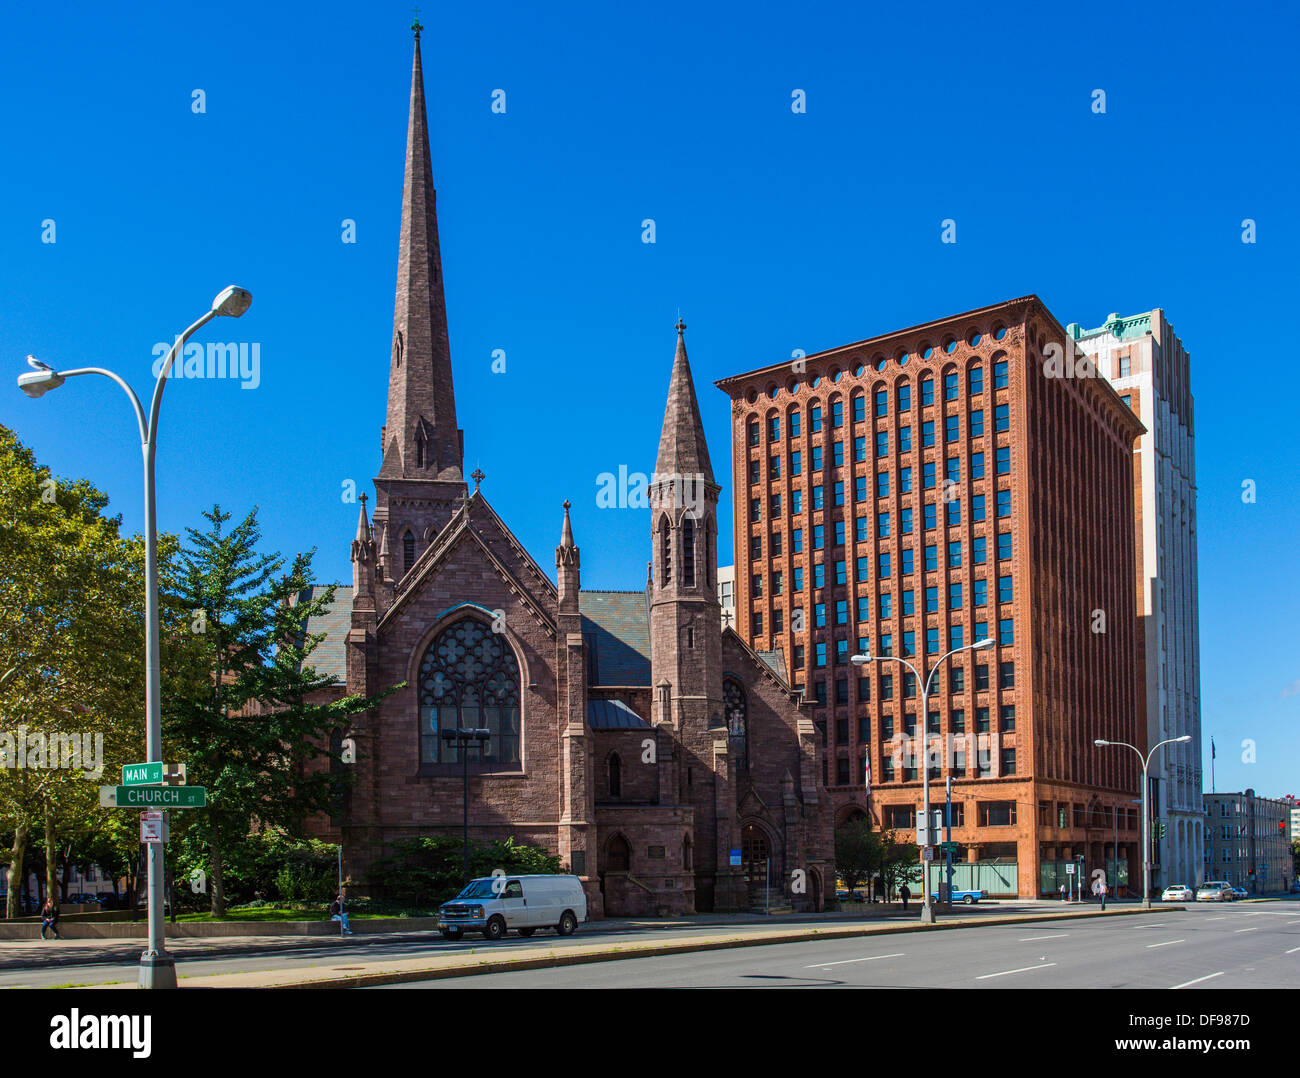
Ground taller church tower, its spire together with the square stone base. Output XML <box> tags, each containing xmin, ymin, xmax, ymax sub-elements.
<box><xmin>374</xmin><ymin>22</ymin><xmax>467</xmax><ymax>589</ymax></box>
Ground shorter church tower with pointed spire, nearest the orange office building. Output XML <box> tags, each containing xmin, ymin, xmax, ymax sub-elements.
<box><xmin>649</xmin><ymin>320</ymin><xmax>733</xmax><ymax>912</ymax></box>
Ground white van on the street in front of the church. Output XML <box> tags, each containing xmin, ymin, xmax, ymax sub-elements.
<box><xmin>438</xmin><ymin>875</ymin><xmax>586</xmax><ymax>940</ymax></box>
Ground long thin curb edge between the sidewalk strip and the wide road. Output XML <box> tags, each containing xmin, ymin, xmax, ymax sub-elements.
<box><xmin>181</xmin><ymin>906</ymin><xmax>1187</xmax><ymax>988</ymax></box>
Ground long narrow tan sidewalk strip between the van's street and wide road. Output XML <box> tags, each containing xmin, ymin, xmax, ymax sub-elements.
<box><xmin>119</xmin><ymin>902</ymin><xmax>1186</xmax><ymax>988</ymax></box>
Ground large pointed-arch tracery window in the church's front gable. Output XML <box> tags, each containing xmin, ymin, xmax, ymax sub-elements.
<box><xmin>420</xmin><ymin>616</ymin><xmax>520</xmax><ymax>770</ymax></box>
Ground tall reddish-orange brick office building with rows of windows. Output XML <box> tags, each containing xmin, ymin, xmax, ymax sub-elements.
<box><xmin>718</xmin><ymin>296</ymin><xmax>1147</xmax><ymax>896</ymax></box>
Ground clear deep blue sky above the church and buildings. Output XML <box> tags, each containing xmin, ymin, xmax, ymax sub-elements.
<box><xmin>0</xmin><ymin>3</ymin><xmax>1300</xmax><ymax>796</ymax></box>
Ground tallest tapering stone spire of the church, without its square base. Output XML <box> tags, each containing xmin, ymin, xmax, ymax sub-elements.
<box><xmin>380</xmin><ymin>27</ymin><xmax>464</xmax><ymax>481</ymax></box>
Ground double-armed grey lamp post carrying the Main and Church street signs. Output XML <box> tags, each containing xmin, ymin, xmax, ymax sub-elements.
<box><xmin>18</xmin><ymin>285</ymin><xmax>252</xmax><ymax>988</ymax></box>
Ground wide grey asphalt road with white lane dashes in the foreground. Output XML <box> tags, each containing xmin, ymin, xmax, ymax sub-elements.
<box><xmin>387</xmin><ymin>901</ymin><xmax>1300</xmax><ymax>991</ymax></box>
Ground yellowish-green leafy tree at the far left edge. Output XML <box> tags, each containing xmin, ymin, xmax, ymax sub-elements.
<box><xmin>0</xmin><ymin>427</ymin><xmax>157</xmax><ymax>917</ymax></box>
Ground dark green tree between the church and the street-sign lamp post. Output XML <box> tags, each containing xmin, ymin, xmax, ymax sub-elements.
<box><xmin>164</xmin><ymin>506</ymin><xmax>398</xmax><ymax>915</ymax></box>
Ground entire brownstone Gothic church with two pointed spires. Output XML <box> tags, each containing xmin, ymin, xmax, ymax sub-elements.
<box><xmin>308</xmin><ymin>25</ymin><xmax>835</xmax><ymax>917</ymax></box>
